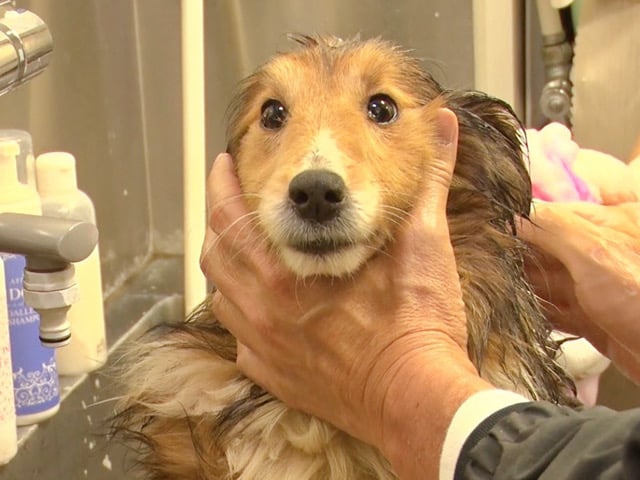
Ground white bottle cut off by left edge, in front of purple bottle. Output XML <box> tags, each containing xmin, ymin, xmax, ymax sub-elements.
<box><xmin>0</xmin><ymin>262</ymin><xmax>18</xmax><ymax>465</ymax></box>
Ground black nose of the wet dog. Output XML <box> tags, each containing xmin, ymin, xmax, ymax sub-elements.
<box><xmin>289</xmin><ymin>170</ymin><xmax>345</xmax><ymax>223</ymax></box>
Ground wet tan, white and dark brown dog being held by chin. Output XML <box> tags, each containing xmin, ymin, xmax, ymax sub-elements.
<box><xmin>115</xmin><ymin>36</ymin><xmax>571</xmax><ymax>480</ymax></box>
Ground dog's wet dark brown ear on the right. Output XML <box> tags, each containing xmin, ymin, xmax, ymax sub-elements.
<box><xmin>444</xmin><ymin>92</ymin><xmax>531</xmax><ymax>231</ymax></box>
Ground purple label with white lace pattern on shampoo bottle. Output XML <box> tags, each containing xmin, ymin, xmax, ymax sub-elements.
<box><xmin>0</xmin><ymin>253</ymin><xmax>60</xmax><ymax>416</ymax></box>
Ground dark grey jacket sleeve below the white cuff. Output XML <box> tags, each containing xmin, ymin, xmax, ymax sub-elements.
<box><xmin>455</xmin><ymin>402</ymin><xmax>640</xmax><ymax>480</ymax></box>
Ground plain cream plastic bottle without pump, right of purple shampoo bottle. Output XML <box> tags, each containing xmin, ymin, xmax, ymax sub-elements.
<box><xmin>36</xmin><ymin>152</ymin><xmax>107</xmax><ymax>375</ymax></box>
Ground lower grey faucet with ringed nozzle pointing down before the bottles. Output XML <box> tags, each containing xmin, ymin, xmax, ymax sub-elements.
<box><xmin>0</xmin><ymin>213</ymin><xmax>98</xmax><ymax>348</ymax></box>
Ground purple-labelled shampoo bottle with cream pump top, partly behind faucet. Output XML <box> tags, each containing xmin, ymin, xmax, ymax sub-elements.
<box><xmin>0</xmin><ymin>141</ymin><xmax>60</xmax><ymax>425</ymax></box>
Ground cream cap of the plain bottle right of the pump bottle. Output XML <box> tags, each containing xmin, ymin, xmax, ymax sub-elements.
<box><xmin>36</xmin><ymin>152</ymin><xmax>78</xmax><ymax>197</ymax></box>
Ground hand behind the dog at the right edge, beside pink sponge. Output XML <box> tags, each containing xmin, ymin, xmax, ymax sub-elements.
<box><xmin>519</xmin><ymin>203</ymin><xmax>640</xmax><ymax>381</ymax></box>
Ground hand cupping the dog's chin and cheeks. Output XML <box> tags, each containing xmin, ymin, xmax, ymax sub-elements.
<box><xmin>201</xmin><ymin>110</ymin><xmax>491</xmax><ymax>478</ymax></box>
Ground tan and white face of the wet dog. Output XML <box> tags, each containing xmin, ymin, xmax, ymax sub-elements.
<box><xmin>229</xmin><ymin>38</ymin><xmax>438</xmax><ymax>276</ymax></box>
